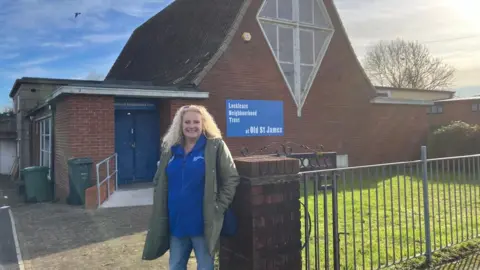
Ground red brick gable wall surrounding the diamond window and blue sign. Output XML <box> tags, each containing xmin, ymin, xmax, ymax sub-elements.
<box><xmin>165</xmin><ymin>0</ymin><xmax>427</xmax><ymax>164</ymax></box>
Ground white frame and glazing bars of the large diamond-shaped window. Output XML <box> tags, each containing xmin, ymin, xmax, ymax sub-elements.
<box><xmin>257</xmin><ymin>0</ymin><xmax>335</xmax><ymax>117</ymax></box>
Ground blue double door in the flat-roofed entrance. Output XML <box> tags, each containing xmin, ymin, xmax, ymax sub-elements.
<box><xmin>115</xmin><ymin>102</ymin><xmax>160</xmax><ymax>185</ymax></box>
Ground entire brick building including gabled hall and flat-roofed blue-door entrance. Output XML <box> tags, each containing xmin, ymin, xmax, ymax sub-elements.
<box><xmin>11</xmin><ymin>0</ymin><xmax>433</xmax><ymax>204</ymax></box>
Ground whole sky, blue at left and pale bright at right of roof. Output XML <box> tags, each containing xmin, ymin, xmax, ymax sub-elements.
<box><xmin>0</xmin><ymin>0</ymin><xmax>480</xmax><ymax>108</ymax></box>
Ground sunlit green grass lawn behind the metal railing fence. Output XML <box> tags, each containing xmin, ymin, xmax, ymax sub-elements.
<box><xmin>300</xmin><ymin>160</ymin><xmax>480</xmax><ymax>269</ymax></box>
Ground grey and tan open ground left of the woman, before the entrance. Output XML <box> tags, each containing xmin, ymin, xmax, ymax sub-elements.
<box><xmin>12</xmin><ymin>203</ymin><xmax>196</xmax><ymax>270</ymax></box>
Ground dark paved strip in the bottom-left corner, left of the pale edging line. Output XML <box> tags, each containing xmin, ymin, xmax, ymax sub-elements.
<box><xmin>0</xmin><ymin>207</ymin><xmax>20</xmax><ymax>270</ymax></box>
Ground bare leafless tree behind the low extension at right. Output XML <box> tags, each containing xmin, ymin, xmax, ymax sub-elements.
<box><xmin>363</xmin><ymin>39</ymin><xmax>455</xmax><ymax>90</ymax></box>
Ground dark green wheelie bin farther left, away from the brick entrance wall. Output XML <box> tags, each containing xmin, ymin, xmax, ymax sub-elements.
<box><xmin>21</xmin><ymin>166</ymin><xmax>53</xmax><ymax>203</ymax></box>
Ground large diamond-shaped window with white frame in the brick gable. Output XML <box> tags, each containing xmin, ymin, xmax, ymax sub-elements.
<box><xmin>258</xmin><ymin>0</ymin><xmax>334</xmax><ymax>115</ymax></box>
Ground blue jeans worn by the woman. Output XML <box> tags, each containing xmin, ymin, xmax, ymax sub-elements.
<box><xmin>169</xmin><ymin>236</ymin><xmax>214</xmax><ymax>270</ymax></box>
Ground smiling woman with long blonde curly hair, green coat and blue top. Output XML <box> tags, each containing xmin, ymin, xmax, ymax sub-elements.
<box><xmin>143</xmin><ymin>105</ymin><xmax>240</xmax><ymax>270</ymax></box>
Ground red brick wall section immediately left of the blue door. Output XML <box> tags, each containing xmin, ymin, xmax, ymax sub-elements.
<box><xmin>54</xmin><ymin>95</ymin><xmax>115</xmax><ymax>200</ymax></box>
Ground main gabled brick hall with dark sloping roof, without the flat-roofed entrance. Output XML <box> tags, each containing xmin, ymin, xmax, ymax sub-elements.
<box><xmin>107</xmin><ymin>0</ymin><xmax>431</xmax><ymax>164</ymax></box>
